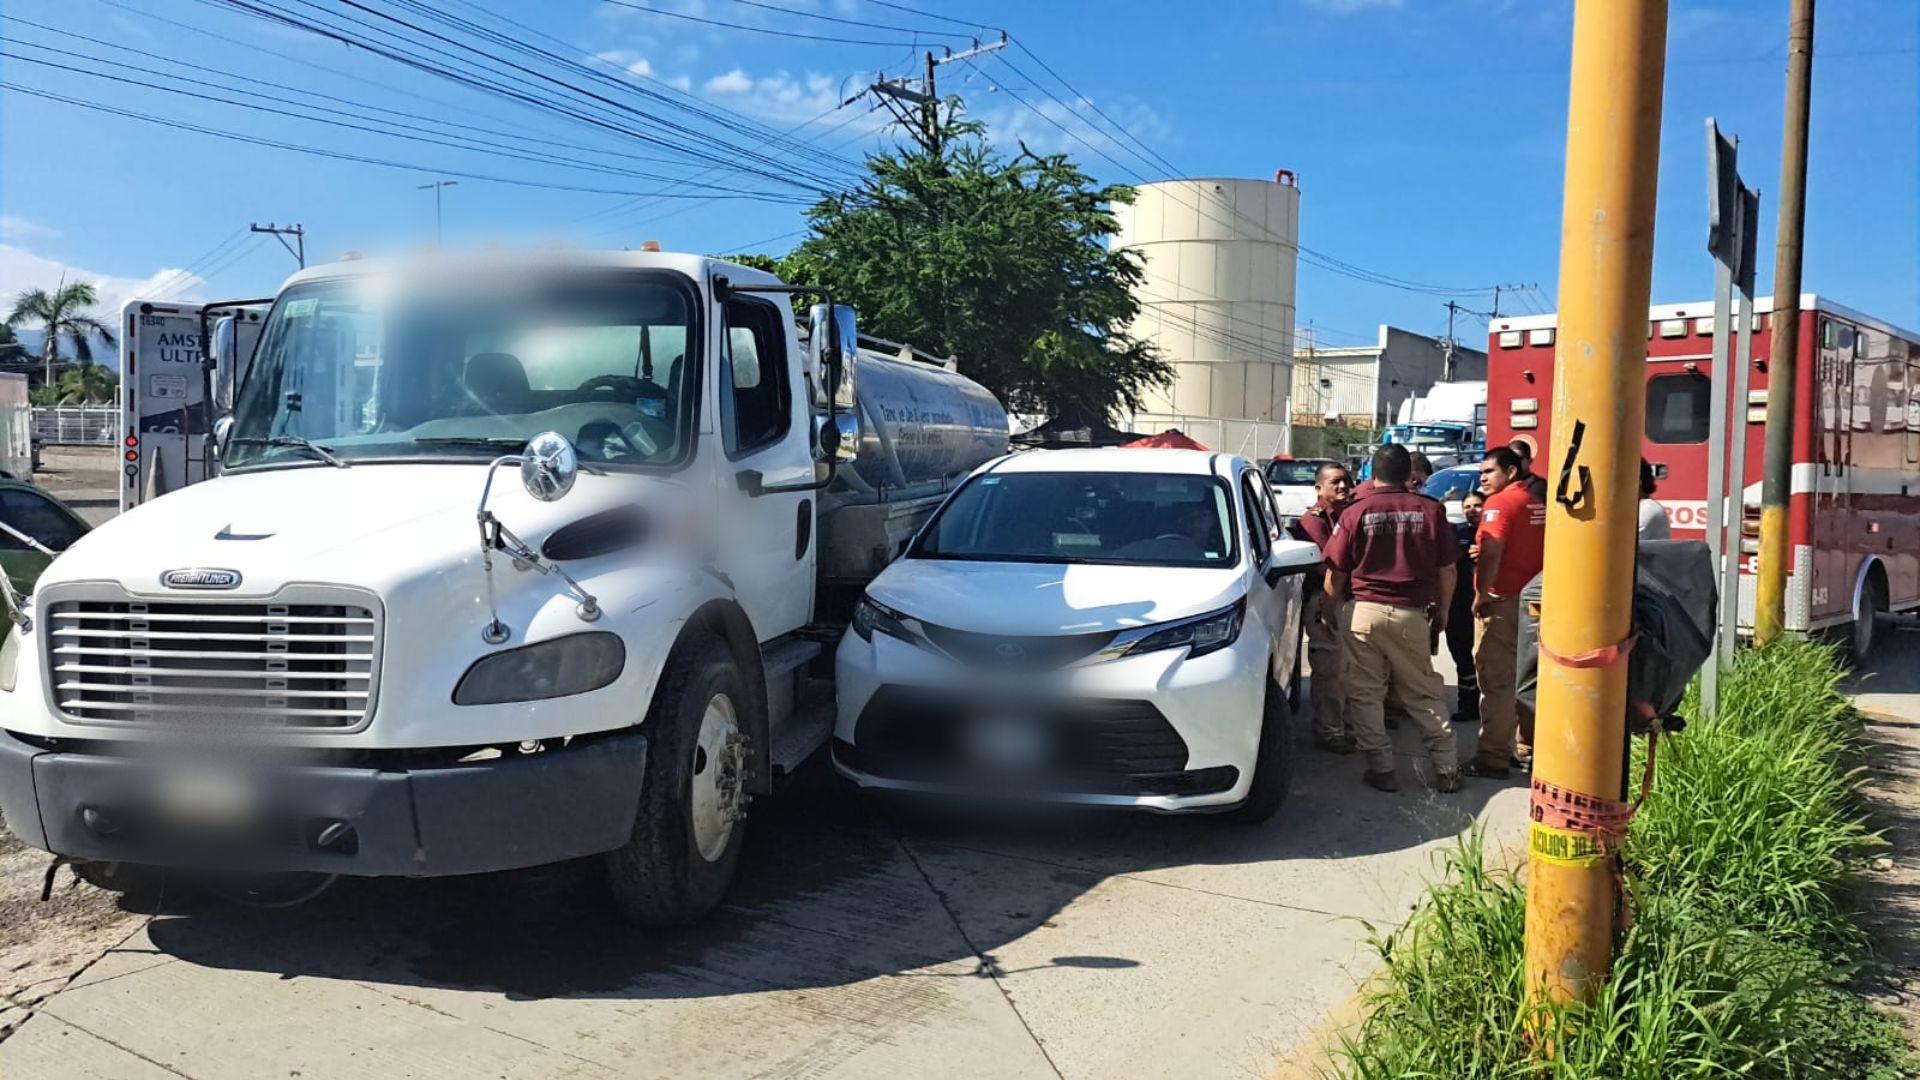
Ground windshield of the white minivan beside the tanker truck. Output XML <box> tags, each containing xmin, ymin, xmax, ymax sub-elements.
<box><xmin>906</xmin><ymin>473</ymin><xmax>1236</xmax><ymax>567</ymax></box>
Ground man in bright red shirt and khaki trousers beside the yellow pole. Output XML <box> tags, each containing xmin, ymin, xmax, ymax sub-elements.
<box><xmin>1463</xmin><ymin>446</ymin><xmax>1548</xmax><ymax>780</ymax></box>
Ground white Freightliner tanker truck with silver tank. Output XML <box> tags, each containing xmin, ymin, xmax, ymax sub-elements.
<box><xmin>0</xmin><ymin>252</ymin><xmax>1006</xmax><ymax>924</ymax></box>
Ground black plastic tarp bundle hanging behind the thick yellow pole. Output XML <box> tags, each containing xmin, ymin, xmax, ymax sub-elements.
<box><xmin>1517</xmin><ymin>540</ymin><xmax>1718</xmax><ymax>728</ymax></box>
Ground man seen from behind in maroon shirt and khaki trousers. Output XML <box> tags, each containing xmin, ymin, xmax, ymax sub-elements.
<box><xmin>1327</xmin><ymin>444</ymin><xmax>1459</xmax><ymax>792</ymax></box>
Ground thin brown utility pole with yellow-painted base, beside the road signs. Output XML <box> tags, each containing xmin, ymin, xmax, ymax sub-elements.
<box><xmin>1753</xmin><ymin>0</ymin><xmax>1812</xmax><ymax>646</ymax></box>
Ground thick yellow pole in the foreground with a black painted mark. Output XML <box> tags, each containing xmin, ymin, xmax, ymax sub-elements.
<box><xmin>1526</xmin><ymin>0</ymin><xmax>1667</xmax><ymax>999</ymax></box>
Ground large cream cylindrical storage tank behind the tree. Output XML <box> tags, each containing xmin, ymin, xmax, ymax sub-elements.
<box><xmin>1114</xmin><ymin>169</ymin><xmax>1300</xmax><ymax>423</ymax></box>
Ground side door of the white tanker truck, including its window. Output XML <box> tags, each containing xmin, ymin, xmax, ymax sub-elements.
<box><xmin>710</xmin><ymin>294</ymin><xmax>818</xmax><ymax>642</ymax></box>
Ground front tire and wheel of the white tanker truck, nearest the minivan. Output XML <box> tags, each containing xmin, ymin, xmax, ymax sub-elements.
<box><xmin>607</xmin><ymin>634</ymin><xmax>753</xmax><ymax>926</ymax></box>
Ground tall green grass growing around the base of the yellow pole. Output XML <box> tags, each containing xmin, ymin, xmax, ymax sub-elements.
<box><xmin>1342</xmin><ymin>642</ymin><xmax>1916</xmax><ymax>1080</ymax></box>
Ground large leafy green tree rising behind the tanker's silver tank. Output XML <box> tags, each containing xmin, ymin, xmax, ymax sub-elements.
<box><xmin>760</xmin><ymin>110</ymin><xmax>1173</xmax><ymax>419</ymax></box>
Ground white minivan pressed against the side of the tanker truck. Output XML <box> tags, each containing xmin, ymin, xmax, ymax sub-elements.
<box><xmin>833</xmin><ymin>450</ymin><xmax>1321</xmax><ymax>821</ymax></box>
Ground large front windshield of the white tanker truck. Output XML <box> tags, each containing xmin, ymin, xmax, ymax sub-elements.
<box><xmin>225</xmin><ymin>273</ymin><xmax>697</xmax><ymax>469</ymax></box>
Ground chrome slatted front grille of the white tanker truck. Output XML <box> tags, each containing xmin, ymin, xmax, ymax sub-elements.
<box><xmin>46</xmin><ymin>600</ymin><xmax>378</xmax><ymax>730</ymax></box>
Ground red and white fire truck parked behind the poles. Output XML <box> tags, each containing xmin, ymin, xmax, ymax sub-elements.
<box><xmin>1486</xmin><ymin>294</ymin><xmax>1920</xmax><ymax>657</ymax></box>
